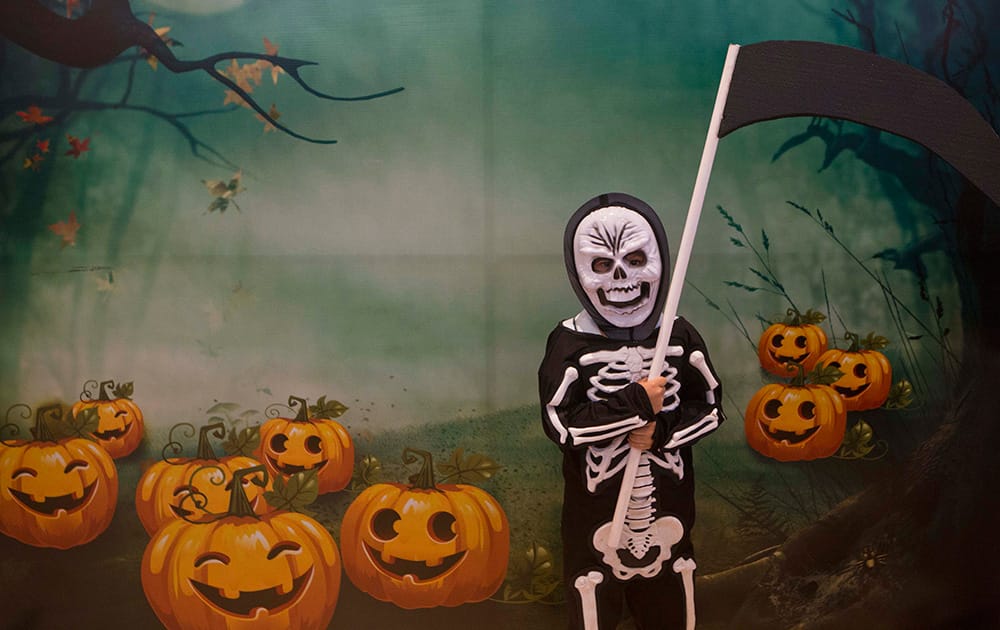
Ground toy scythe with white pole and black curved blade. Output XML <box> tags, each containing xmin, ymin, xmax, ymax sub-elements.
<box><xmin>608</xmin><ymin>41</ymin><xmax>1000</xmax><ymax>564</ymax></box>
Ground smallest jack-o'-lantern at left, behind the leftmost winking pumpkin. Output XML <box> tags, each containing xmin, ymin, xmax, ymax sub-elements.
<box><xmin>71</xmin><ymin>381</ymin><xmax>145</xmax><ymax>459</ymax></box>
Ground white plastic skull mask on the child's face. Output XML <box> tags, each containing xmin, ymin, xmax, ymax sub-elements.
<box><xmin>573</xmin><ymin>206</ymin><xmax>663</xmax><ymax>328</ymax></box>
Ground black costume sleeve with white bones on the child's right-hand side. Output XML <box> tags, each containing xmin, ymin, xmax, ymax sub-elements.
<box><xmin>663</xmin><ymin>319</ymin><xmax>725</xmax><ymax>449</ymax></box>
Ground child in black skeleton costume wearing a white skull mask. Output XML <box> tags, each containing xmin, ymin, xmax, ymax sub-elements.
<box><xmin>539</xmin><ymin>193</ymin><xmax>723</xmax><ymax>630</ymax></box>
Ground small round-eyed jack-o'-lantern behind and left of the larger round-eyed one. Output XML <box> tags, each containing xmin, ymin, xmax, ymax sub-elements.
<box><xmin>254</xmin><ymin>396</ymin><xmax>354</xmax><ymax>494</ymax></box>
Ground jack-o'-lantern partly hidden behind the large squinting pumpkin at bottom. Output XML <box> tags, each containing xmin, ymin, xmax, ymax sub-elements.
<box><xmin>135</xmin><ymin>422</ymin><xmax>269</xmax><ymax>535</ymax></box>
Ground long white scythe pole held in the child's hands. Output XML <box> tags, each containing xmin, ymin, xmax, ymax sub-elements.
<box><xmin>608</xmin><ymin>44</ymin><xmax>740</xmax><ymax>548</ymax></box>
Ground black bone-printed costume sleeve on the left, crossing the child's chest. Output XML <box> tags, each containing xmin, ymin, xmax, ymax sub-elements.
<box><xmin>538</xmin><ymin>329</ymin><xmax>654</xmax><ymax>449</ymax></box>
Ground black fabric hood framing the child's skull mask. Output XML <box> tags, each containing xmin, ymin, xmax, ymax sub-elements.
<box><xmin>563</xmin><ymin>193</ymin><xmax>670</xmax><ymax>341</ymax></box>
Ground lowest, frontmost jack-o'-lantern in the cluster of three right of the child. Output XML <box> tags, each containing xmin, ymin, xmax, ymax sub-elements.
<box><xmin>743</xmin><ymin>364</ymin><xmax>847</xmax><ymax>462</ymax></box>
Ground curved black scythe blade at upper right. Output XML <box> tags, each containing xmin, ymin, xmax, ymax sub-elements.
<box><xmin>719</xmin><ymin>41</ymin><xmax>1000</xmax><ymax>205</ymax></box>
